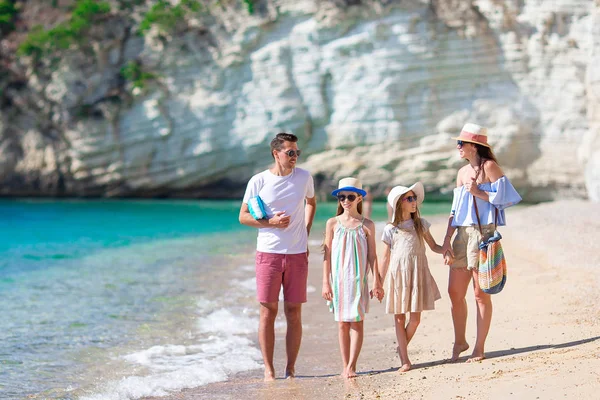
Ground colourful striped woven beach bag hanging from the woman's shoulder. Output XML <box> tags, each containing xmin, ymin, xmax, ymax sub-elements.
<box><xmin>474</xmin><ymin>201</ymin><xmax>506</xmax><ymax>294</ymax></box>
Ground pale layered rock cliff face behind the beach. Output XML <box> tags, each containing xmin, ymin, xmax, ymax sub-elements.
<box><xmin>0</xmin><ymin>0</ymin><xmax>600</xmax><ymax>201</ymax></box>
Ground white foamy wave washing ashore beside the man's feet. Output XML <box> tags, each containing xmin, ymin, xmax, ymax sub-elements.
<box><xmin>81</xmin><ymin>309</ymin><xmax>262</xmax><ymax>400</ymax></box>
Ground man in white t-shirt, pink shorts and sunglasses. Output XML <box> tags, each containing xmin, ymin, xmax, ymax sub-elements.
<box><xmin>240</xmin><ymin>133</ymin><xmax>317</xmax><ymax>381</ymax></box>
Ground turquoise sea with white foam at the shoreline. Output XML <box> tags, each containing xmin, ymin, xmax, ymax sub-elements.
<box><xmin>0</xmin><ymin>200</ymin><xmax>449</xmax><ymax>399</ymax></box>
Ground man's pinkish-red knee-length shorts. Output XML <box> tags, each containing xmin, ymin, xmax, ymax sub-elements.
<box><xmin>256</xmin><ymin>251</ymin><xmax>308</xmax><ymax>303</ymax></box>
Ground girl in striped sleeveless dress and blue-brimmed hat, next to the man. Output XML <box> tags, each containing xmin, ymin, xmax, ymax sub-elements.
<box><xmin>322</xmin><ymin>178</ymin><xmax>383</xmax><ymax>378</ymax></box>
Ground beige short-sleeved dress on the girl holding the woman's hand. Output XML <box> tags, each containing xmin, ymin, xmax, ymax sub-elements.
<box><xmin>382</xmin><ymin>218</ymin><xmax>442</xmax><ymax>314</ymax></box>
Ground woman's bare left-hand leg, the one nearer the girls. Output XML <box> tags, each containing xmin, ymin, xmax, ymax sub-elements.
<box><xmin>448</xmin><ymin>268</ymin><xmax>472</xmax><ymax>362</ymax></box>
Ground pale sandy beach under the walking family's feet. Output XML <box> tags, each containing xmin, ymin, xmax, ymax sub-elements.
<box><xmin>146</xmin><ymin>200</ymin><xmax>600</xmax><ymax>400</ymax></box>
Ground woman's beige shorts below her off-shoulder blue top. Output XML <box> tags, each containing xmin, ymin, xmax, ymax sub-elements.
<box><xmin>450</xmin><ymin>224</ymin><xmax>495</xmax><ymax>271</ymax></box>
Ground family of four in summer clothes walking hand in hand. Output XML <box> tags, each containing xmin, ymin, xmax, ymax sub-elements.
<box><xmin>239</xmin><ymin>123</ymin><xmax>521</xmax><ymax>381</ymax></box>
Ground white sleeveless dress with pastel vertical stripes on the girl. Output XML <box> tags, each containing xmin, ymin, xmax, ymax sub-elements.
<box><xmin>329</xmin><ymin>218</ymin><xmax>369</xmax><ymax>322</ymax></box>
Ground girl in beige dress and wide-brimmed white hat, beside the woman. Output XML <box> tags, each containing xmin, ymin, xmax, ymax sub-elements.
<box><xmin>381</xmin><ymin>182</ymin><xmax>442</xmax><ymax>372</ymax></box>
